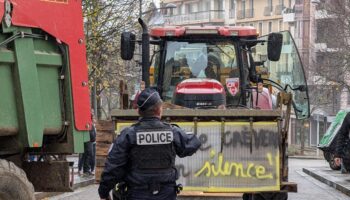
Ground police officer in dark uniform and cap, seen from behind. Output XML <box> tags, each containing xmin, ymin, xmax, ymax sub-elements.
<box><xmin>98</xmin><ymin>88</ymin><xmax>201</xmax><ymax>200</ymax></box>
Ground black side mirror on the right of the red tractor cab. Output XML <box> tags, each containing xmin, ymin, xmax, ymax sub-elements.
<box><xmin>267</xmin><ymin>33</ymin><xmax>283</xmax><ymax>61</ymax></box>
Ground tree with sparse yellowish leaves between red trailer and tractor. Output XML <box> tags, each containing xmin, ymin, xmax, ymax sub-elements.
<box><xmin>83</xmin><ymin>0</ymin><xmax>152</xmax><ymax>118</ymax></box>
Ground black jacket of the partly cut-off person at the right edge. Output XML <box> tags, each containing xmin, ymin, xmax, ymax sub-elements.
<box><xmin>335</xmin><ymin>113</ymin><xmax>350</xmax><ymax>158</ymax></box>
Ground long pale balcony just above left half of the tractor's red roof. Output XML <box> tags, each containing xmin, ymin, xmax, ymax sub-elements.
<box><xmin>164</xmin><ymin>10</ymin><xmax>225</xmax><ymax>25</ymax></box>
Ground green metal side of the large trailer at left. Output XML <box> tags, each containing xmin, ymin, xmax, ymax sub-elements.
<box><xmin>0</xmin><ymin>24</ymin><xmax>89</xmax><ymax>155</ymax></box>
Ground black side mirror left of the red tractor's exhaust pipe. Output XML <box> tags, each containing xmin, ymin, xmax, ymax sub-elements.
<box><xmin>120</xmin><ymin>32</ymin><xmax>136</xmax><ymax>60</ymax></box>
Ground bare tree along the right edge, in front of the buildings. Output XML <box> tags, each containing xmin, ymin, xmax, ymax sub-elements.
<box><xmin>310</xmin><ymin>0</ymin><xmax>350</xmax><ymax>113</ymax></box>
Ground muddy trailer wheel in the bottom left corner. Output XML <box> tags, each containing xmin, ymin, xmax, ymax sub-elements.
<box><xmin>0</xmin><ymin>159</ymin><xmax>35</xmax><ymax>200</ymax></box>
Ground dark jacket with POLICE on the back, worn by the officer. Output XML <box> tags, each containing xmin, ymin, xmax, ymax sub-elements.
<box><xmin>98</xmin><ymin>117</ymin><xmax>201</xmax><ymax>198</ymax></box>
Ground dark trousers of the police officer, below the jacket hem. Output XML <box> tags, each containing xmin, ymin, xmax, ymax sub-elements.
<box><xmin>127</xmin><ymin>185</ymin><xmax>177</xmax><ymax>200</ymax></box>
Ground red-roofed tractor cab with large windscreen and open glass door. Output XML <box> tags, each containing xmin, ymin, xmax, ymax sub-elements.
<box><xmin>123</xmin><ymin>26</ymin><xmax>309</xmax><ymax>119</ymax></box>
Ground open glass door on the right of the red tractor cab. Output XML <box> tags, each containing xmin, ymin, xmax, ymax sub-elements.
<box><xmin>253</xmin><ymin>31</ymin><xmax>310</xmax><ymax>119</ymax></box>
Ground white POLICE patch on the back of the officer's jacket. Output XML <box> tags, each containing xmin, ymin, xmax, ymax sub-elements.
<box><xmin>136</xmin><ymin>131</ymin><xmax>174</xmax><ymax>145</ymax></box>
